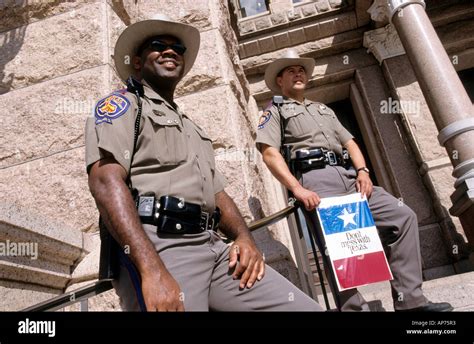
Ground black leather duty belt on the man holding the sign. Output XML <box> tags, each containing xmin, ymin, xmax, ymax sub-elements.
<box><xmin>291</xmin><ymin>148</ymin><xmax>349</xmax><ymax>173</ymax></box>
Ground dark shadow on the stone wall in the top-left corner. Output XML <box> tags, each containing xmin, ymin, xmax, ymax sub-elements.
<box><xmin>0</xmin><ymin>0</ymin><xmax>28</xmax><ymax>94</ymax></box>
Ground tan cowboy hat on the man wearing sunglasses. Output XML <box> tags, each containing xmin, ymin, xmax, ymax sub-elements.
<box><xmin>114</xmin><ymin>14</ymin><xmax>201</xmax><ymax>80</ymax></box>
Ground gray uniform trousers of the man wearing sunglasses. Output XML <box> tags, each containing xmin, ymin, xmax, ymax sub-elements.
<box><xmin>113</xmin><ymin>225</ymin><xmax>322</xmax><ymax>311</ymax></box>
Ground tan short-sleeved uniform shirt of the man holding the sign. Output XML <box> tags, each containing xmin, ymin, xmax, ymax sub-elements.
<box><xmin>256</xmin><ymin>98</ymin><xmax>353</xmax><ymax>158</ymax></box>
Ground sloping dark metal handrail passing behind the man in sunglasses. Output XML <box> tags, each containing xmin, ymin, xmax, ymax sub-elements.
<box><xmin>22</xmin><ymin>202</ymin><xmax>298</xmax><ymax>312</ymax></box>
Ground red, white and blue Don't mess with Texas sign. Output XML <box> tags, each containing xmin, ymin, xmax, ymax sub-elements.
<box><xmin>317</xmin><ymin>193</ymin><xmax>393</xmax><ymax>291</ymax></box>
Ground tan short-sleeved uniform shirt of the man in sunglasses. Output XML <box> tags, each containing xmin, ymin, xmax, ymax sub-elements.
<box><xmin>86</xmin><ymin>83</ymin><xmax>225</xmax><ymax>212</ymax></box>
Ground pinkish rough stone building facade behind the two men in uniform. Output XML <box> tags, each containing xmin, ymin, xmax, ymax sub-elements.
<box><xmin>0</xmin><ymin>0</ymin><xmax>474</xmax><ymax>310</ymax></box>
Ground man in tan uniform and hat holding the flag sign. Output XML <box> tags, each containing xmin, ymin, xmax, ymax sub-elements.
<box><xmin>256</xmin><ymin>50</ymin><xmax>452</xmax><ymax>311</ymax></box>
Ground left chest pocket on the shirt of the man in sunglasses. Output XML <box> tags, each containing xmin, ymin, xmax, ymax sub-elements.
<box><xmin>150</xmin><ymin>113</ymin><xmax>188</xmax><ymax>166</ymax></box>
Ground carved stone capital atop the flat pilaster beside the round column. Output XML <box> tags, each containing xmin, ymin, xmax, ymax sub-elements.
<box><xmin>364</xmin><ymin>24</ymin><xmax>405</xmax><ymax>64</ymax></box>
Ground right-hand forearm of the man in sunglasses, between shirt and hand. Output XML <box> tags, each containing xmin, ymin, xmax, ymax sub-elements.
<box><xmin>215</xmin><ymin>191</ymin><xmax>252</xmax><ymax>240</ymax></box>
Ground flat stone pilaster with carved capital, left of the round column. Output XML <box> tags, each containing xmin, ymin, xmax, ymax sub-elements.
<box><xmin>362</xmin><ymin>25</ymin><xmax>467</xmax><ymax>279</ymax></box>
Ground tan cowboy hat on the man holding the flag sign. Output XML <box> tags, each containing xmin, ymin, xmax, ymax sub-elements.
<box><xmin>265</xmin><ymin>49</ymin><xmax>314</xmax><ymax>93</ymax></box>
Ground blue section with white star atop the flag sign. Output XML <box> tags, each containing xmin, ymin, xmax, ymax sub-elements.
<box><xmin>318</xmin><ymin>200</ymin><xmax>375</xmax><ymax>235</ymax></box>
